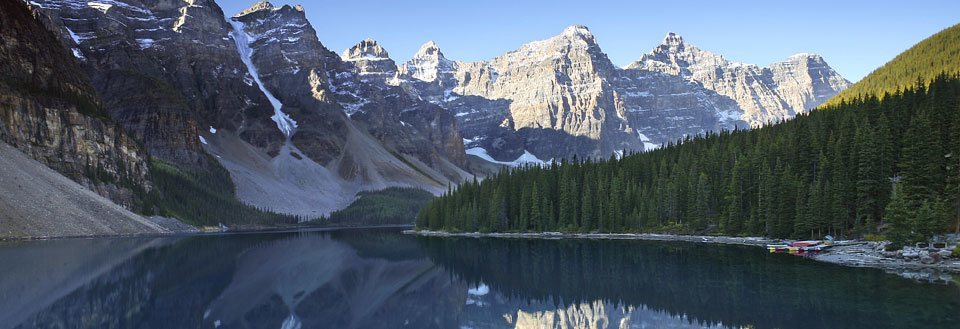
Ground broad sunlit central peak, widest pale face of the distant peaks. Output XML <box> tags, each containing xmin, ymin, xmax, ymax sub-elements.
<box><xmin>448</xmin><ymin>26</ymin><xmax>641</xmax><ymax>159</ymax></box>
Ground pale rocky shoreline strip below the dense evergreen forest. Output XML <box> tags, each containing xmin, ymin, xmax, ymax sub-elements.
<box><xmin>403</xmin><ymin>229</ymin><xmax>960</xmax><ymax>282</ymax></box>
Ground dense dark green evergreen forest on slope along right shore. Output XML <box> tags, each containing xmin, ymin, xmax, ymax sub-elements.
<box><xmin>417</xmin><ymin>75</ymin><xmax>960</xmax><ymax>243</ymax></box>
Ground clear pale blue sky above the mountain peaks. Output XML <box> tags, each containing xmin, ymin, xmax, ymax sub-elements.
<box><xmin>218</xmin><ymin>0</ymin><xmax>960</xmax><ymax>81</ymax></box>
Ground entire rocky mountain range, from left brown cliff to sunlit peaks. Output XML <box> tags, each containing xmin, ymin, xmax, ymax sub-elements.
<box><xmin>3</xmin><ymin>0</ymin><xmax>848</xmax><ymax>231</ymax></box>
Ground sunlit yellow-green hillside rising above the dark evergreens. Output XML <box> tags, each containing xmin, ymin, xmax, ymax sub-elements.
<box><xmin>829</xmin><ymin>24</ymin><xmax>960</xmax><ymax>105</ymax></box>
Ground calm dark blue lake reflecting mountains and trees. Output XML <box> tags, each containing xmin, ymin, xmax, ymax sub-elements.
<box><xmin>0</xmin><ymin>229</ymin><xmax>960</xmax><ymax>329</ymax></box>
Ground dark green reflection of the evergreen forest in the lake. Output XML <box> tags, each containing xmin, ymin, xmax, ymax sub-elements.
<box><xmin>417</xmin><ymin>237</ymin><xmax>960</xmax><ymax>328</ymax></box>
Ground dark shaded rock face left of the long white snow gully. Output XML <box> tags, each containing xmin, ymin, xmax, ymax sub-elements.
<box><xmin>34</xmin><ymin>0</ymin><xmax>283</xmax><ymax>170</ymax></box>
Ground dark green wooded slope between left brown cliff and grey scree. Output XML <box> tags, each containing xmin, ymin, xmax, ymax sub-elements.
<box><xmin>144</xmin><ymin>159</ymin><xmax>302</xmax><ymax>227</ymax></box>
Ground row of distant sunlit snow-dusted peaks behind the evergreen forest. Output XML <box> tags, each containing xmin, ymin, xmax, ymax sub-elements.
<box><xmin>377</xmin><ymin>25</ymin><xmax>848</xmax><ymax>164</ymax></box>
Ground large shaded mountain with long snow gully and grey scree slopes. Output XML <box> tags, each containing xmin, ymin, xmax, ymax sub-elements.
<box><xmin>31</xmin><ymin>0</ymin><xmax>470</xmax><ymax>220</ymax></box>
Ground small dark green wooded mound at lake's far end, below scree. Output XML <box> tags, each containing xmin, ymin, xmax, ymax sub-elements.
<box><xmin>329</xmin><ymin>187</ymin><xmax>433</xmax><ymax>225</ymax></box>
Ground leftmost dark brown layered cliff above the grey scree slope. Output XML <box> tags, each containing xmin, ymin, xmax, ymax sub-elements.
<box><xmin>0</xmin><ymin>1</ymin><xmax>151</xmax><ymax>207</ymax></box>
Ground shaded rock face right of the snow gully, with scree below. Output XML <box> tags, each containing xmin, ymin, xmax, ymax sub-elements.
<box><xmin>207</xmin><ymin>2</ymin><xmax>469</xmax><ymax>216</ymax></box>
